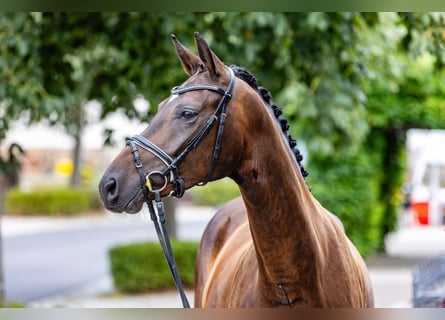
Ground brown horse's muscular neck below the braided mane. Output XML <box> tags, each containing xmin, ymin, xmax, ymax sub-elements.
<box><xmin>229</xmin><ymin>90</ymin><xmax>327</xmax><ymax>302</ymax></box>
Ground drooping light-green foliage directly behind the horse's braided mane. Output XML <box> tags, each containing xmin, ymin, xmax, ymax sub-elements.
<box><xmin>193</xmin><ymin>13</ymin><xmax>377</xmax><ymax>154</ymax></box>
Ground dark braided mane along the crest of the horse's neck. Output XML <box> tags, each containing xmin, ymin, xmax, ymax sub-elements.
<box><xmin>230</xmin><ymin>65</ymin><xmax>309</xmax><ymax>177</ymax></box>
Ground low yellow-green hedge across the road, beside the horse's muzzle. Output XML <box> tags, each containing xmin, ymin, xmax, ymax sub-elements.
<box><xmin>5</xmin><ymin>186</ymin><xmax>98</xmax><ymax>216</ymax></box>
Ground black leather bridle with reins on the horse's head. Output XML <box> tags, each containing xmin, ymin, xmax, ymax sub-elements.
<box><xmin>127</xmin><ymin>68</ymin><xmax>235</xmax><ymax>308</ymax></box>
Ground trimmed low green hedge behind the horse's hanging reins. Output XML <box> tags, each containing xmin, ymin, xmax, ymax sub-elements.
<box><xmin>109</xmin><ymin>241</ymin><xmax>199</xmax><ymax>293</ymax></box>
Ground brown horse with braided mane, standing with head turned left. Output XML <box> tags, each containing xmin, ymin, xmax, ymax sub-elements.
<box><xmin>99</xmin><ymin>33</ymin><xmax>373</xmax><ymax>307</ymax></box>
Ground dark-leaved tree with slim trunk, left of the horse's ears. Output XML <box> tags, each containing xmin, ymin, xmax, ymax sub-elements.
<box><xmin>37</xmin><ymin>13</ymin><xmax>212</xmax><ymax>185</ymax></box>
